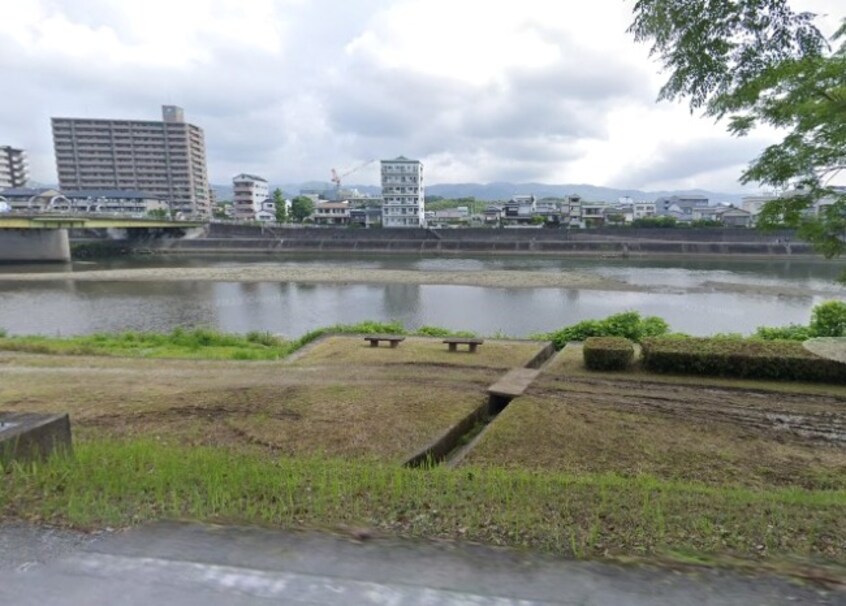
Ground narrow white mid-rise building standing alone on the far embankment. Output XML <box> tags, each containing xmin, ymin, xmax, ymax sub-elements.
<box><xmin>382</xmin><ymin>156</ymin><xmax>426</xmax><ymax>227</ymax></box>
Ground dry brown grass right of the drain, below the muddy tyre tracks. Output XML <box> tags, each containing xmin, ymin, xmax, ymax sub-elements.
<box><xmin>462</xmin><ymin>394</ymin><xmax>846</xmax><ymax>490</ymax></box>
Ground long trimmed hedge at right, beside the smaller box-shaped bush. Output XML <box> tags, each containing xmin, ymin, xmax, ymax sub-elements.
<box><xmin>641</xmin><ymin>337</ymin><xmax>846</xmax><ymax>383</ymax></box>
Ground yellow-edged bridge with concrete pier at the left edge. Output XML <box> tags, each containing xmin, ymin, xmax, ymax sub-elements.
<box><xmin>0</xmin><ymin>214</ymin><xmax>204</xmax><ymax>263</ymax></box>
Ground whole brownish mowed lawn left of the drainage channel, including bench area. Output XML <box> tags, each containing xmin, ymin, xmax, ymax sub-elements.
<box><xmin>0</xmin><ymin>337</ymin><xmax>528</xmax><ymax>463</ymax></box>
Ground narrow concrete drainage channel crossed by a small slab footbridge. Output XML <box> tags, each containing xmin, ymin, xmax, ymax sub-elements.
<box><xmin>404</xmin><ymin>343</ymin><xmax>555</xmax><ymax>467</ymax></box>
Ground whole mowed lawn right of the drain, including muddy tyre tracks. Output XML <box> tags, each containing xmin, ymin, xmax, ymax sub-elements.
<box><xmin>462</xmin><ymin>350</ymin><xmax>846</xmax><ymax>490</ymax></box>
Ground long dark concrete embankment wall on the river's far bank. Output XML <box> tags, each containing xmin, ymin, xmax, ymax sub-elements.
<box><xmin>129</xmin><ymin>224</ymin><xmax>814</xmax><ymax>257</ymax></box>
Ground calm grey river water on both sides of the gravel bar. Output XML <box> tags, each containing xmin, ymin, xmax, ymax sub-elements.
<box><xmin>0</xmin><ymin>255</ymin><xmax>846</xmax><ymax>337</ymax></box>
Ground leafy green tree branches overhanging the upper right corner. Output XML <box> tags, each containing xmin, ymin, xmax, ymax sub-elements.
<box><xmin>629</xmin><ymin>0</ymin><xmax>846</xmax><ymax>258</ymax></box>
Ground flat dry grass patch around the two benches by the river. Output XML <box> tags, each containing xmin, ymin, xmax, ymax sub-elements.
<box><xmin>291</xmin><ymin>336</ymin><xmax>546</xmax><ymax>372</ymax></box>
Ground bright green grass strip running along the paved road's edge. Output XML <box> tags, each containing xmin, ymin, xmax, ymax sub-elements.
<box><xmin>0</xmin><ymin>441</ymin><xmax>846</xmax><ymax>562</ymax></box>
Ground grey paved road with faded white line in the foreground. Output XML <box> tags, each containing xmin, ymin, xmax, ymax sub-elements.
<box><xmin>0</xmin><ymin>523</ymin><xmax>846</xmax><ymax>606</ymax></box>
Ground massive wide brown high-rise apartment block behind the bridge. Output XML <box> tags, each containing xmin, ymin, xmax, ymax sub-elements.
<box><xmin>51</xmin><ymin>105</ymin><xmax>211</xmax><ymax>216</ymax></box>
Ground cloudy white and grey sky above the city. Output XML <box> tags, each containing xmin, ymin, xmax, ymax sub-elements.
<box><xmin>0</xmin><ymin>0</ymin><xmax>843</xmax><ymax>192</ymax></box>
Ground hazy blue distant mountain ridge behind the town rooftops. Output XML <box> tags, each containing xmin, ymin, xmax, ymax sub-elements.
<box><xmin>212</xmin><ymin>181</ymin><xmax>743</xmax><ymax>204</ymax></box>
